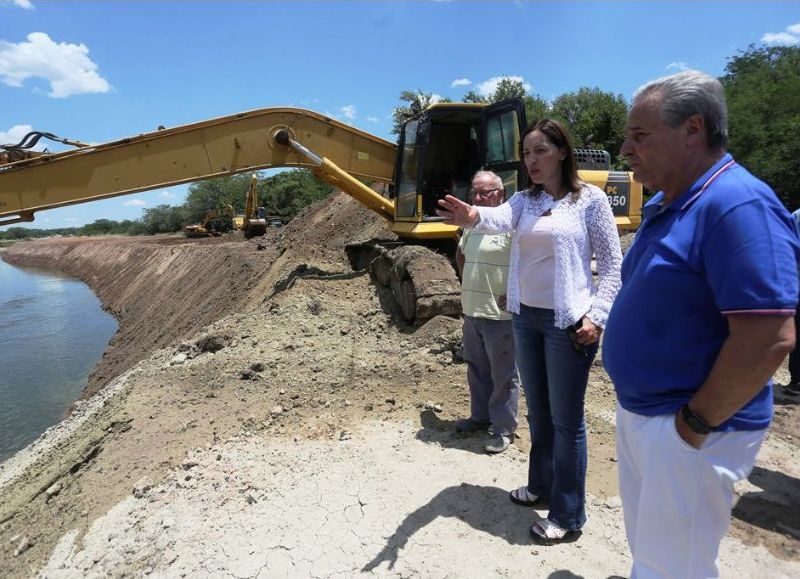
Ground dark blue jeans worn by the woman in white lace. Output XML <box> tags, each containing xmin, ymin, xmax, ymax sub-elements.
<box><xmin>513</xmin><ymin>304</ymin><xmax>597</xmax><ymax>531</ymax></box>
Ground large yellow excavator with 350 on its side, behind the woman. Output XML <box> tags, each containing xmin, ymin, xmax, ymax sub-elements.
<box><xmin>0</xmin><ymin>99</ymin><xmax>642</xmax><ymax>320</ymax></box>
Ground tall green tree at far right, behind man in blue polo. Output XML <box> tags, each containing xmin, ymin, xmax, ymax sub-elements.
<box><xmin>720</xmin><ymin>46</ymin><xmax>800</xmax><ymax>210</ymax></box>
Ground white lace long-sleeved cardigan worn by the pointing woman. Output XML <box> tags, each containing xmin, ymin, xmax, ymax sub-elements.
<box><xmin>475</xmin><ymin>183</ymin><xmax>622</xmax><ymax>328</ymax></box>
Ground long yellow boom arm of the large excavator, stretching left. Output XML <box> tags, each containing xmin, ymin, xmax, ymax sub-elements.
<box><xmin>0</xmin><ymin>108</ymin><xmax>397</xmax><ymax>225</ymax></box>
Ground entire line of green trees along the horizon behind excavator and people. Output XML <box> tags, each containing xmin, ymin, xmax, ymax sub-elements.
<box><xmin>0</xmin><ymin>46</ymin><xmax>800</xmax><ymax>240</ymax></box>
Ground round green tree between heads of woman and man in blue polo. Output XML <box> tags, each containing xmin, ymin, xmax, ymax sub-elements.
<box><xmin>551</xmin><ymin>87</ymin><xmax>628</xmax><ymax>164</ymax></box>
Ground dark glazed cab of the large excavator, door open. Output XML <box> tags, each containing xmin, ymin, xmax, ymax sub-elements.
<box><xmin>394</xmin><ymin>99</ymin><xmax>525</xmax><ymax>223</ymax></box>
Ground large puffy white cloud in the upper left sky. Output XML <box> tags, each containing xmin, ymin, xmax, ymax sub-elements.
<box><xmin>0</xmin><ymin>32</ymin><xmax>111</xmax><ymax>98</ymax></box>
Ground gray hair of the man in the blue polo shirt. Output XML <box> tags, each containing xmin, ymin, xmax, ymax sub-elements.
<box><xmin>633</xmin><ymin>70</ymin><xmax>728</xmax><ymax>148</ymax></box>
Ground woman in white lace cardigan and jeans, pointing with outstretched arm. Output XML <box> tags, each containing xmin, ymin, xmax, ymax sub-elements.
<box><xmin>438</xmin><ymin>119</ymin><xmax>622</xmax><ymax>542</ymax></box>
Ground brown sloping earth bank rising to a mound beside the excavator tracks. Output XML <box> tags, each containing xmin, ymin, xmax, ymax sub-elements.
<box><xmin>4</xmin><ymin>194</ymin><xmax>392</xmax><ymax>396</ymax></box>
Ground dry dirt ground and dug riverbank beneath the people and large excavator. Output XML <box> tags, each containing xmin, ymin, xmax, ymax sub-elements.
<box><xmin>0</xmin><ymin>195</ymin><xmax>800</xmax><ymax>577</ymax></box>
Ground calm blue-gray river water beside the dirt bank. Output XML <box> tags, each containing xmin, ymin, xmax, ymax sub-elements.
<box><xmin>0</xmin><ymin>259</ymin><xmax>117</xmax><ymax>462</ymax></box>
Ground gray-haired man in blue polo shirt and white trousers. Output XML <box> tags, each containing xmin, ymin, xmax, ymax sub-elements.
<box><xmin>603</xmin><ymin>71</ymin><xmax>800</xmax><ymax>578</ymax></box>
